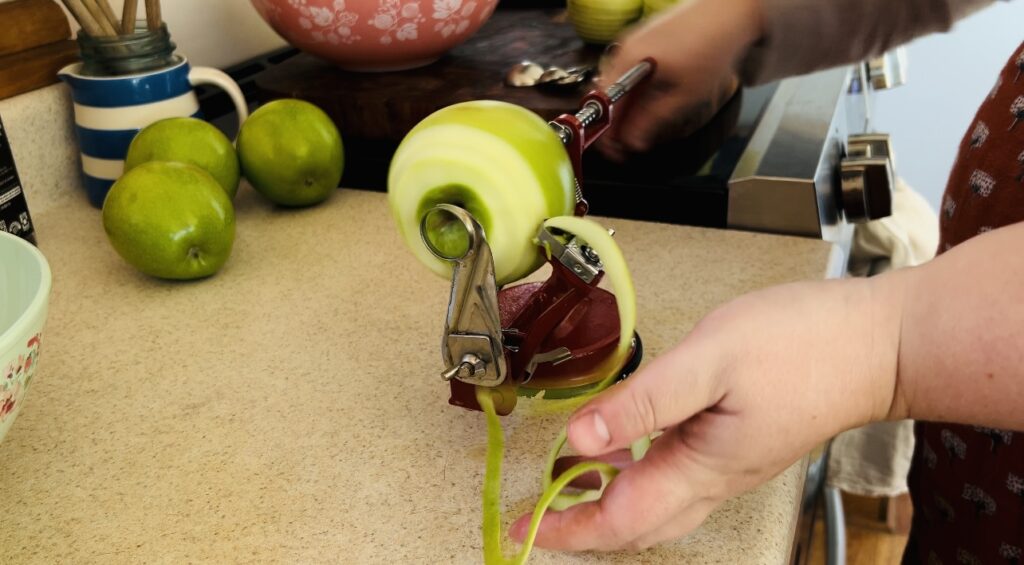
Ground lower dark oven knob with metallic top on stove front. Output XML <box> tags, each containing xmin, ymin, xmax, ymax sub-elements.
<box><xmin>840</xmin><ymin>133</ymin><xmax>894</xmax><ymax>223</ymax></box>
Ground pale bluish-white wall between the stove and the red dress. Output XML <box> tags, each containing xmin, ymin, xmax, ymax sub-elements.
<box><xmin>874</xmin><ymin>0</ymin><xmax>1024</xmax><ymax>210</ymax></box>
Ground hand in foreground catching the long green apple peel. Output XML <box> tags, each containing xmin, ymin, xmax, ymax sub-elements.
<box><xmin>511</xmin><ymin>277</ymin><xmax>901</xmax><ymax>551</ymax></box>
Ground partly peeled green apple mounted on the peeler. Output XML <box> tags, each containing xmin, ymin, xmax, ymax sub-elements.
<box><xmin>388</xmin><ymin>100</ymin><xmax>575</xmax><ymax>285</ymax></box>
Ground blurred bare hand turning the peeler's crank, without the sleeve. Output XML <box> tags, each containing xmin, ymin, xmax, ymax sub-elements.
<box><xmin>598</xmin><ymin>0</ymin><xmax>761</xmax><ymax>160</ymax></box>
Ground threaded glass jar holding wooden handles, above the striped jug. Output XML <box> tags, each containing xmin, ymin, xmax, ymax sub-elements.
<box><xmin>77</xmin><ymin>20</ymin><xmax>181</xmax><ymax>77</ymax></box>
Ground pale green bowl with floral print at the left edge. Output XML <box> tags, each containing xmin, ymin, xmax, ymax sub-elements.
<box><xmin>0</xmin><ymin>231</ymin><xmax>50</xmax><ymax>441</ymax></box>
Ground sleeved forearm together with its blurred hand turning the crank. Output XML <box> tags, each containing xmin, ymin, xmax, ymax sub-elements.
<box><xmin>599</xmin><ymin>0</ymin><xmax>991</xmax><ymax>154</ymax></box>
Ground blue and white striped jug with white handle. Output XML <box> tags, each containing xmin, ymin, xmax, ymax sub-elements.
<box><xmin>57</xmin><ymin>57</ymin><xmax>249</xmax><ymax>208</ymax></box>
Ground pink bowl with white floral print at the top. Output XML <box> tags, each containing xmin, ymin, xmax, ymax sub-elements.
<box><xmin>252</xmin><ymin>0</ymin><xmax>498</xmax><ymax>72</ymax></box>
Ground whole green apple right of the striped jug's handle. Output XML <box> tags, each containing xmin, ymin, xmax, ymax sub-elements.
<box><xmin>239</xmin><ymin>99</ymin><xmax>345</xmax><ymax>206</ymax></box>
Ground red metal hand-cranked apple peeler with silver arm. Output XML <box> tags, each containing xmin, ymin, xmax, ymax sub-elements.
<box><xmin>420</xmin><ymin>59</ymin><xmax>654</xmax><ymax>415</ymax></box>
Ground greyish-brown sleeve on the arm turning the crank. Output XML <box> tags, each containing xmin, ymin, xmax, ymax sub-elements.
<box><xmin>740</xmin><ymin>0</ymin><xmax>992</xmax><ymax>84</ymax></box>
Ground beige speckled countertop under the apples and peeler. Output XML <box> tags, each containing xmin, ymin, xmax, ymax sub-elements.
<box><xmin>0</xmin><ymin>187</ymin><xmax>830</xmax><ymax>564</ymax></box>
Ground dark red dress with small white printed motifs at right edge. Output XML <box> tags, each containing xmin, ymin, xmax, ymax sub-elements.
<box><xmin>903</xmin><ymin>43</ymin><xmax>1024</xmax><ymax>565</ymax></box>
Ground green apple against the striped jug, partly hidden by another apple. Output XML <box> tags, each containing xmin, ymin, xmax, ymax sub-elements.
<box><xmin>125</xmin><ymin>118</ymin><xmax>242</xmax><ymax>199</ymax></box>
